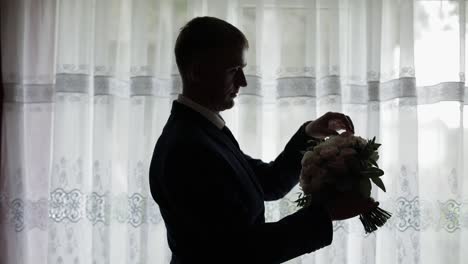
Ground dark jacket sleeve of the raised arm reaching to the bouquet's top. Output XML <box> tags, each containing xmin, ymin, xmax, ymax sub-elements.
<box><xmin>244</xmin><ymin>121</ymin><xmax>313</xmax><ymax>201</ymax></box>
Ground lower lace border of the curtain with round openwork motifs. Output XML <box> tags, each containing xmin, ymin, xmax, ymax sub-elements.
<box><xmin>0</xmin><ymin>191</ymin><xmax>468</xmax><ymax>233</ymax></box>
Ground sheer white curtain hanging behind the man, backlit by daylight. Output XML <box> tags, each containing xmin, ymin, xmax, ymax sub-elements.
<box><xmin>0</xmin><ymin>0</ymin><xmax>468</xmax><ymax>264</ymax></box>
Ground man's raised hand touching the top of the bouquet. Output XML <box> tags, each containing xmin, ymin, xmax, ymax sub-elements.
<box><xmin>305</xmin><ymin>112</ymin><xmax>354</xmax><ymax>138</ymax></box>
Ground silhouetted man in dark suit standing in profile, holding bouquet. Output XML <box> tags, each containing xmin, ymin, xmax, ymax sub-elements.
<box><xmin>150</xmin><ymin>17</ymin><xmax>373</xmax><ymax>263</ymax></box>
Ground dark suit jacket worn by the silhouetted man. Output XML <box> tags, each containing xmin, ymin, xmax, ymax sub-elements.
<box><xmin>150</xmin><ymin>101</ymin><xmax>332</xmax><ymax>263</ymax></box>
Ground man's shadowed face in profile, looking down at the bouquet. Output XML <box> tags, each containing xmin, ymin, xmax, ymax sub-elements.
<box><xmin>198</xmin><ymin>47</ymin><xmax>247</xmax><ymax>111</ymax></box>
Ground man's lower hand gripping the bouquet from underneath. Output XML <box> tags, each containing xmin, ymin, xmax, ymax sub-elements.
<box><xmin>325</xmin><ymin>192</ymin><xmax>379</xmax><ymax>221</ymax></box>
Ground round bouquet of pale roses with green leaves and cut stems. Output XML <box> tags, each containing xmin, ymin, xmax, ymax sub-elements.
<box><xmin>296</xmin><ymin>134</ymin><xmax>391</xmax><ymax>233</ymax></box>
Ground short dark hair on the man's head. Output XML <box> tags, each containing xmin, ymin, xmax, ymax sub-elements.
<box><xmin>174</xmin><ymin>16</ymin><xmax>249</xmax><ymax>81</ymax></box>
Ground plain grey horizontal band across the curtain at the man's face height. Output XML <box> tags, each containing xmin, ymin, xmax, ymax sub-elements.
<box><xmin>4</xmin><ymin>74</ymin><xmax>468</xmax><ymax>104</ymax></box>
